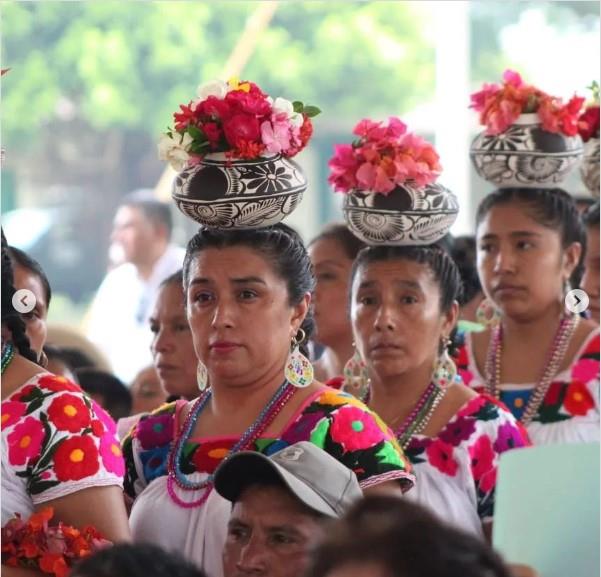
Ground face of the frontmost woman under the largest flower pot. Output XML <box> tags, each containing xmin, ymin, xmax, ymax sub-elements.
<box><xmin>187</xmin><ymin>246</ymin><xmax>310</xmax><ymax>386</ymax></box>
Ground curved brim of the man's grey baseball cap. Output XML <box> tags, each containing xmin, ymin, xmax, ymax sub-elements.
<box><xmin>215</xmin><ymin>451</ymin><xmax>338</xmax><ymax>517</ymax></box>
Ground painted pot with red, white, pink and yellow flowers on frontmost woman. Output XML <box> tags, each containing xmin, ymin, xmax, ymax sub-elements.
<box><xmin>159</xmin><ymin>79</ymin><xmax>320</xmax><ymax>228</ymax></box>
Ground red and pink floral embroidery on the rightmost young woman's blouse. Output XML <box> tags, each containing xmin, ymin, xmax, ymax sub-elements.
<box><xmin>455</xmin><ymin>332</ymin><xmax>599</xmax><ymax>424</ymax></box>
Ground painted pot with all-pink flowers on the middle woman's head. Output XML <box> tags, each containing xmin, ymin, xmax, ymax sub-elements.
<box><xmin>328</xmin><ymin>117</ymin><xmax>459</xmax><ymax>245</ymax></box>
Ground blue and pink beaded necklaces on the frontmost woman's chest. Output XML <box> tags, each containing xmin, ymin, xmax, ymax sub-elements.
<box><xmin>167</xmin><ymin>381</ymin><xmax>297</xmax><ymax>509</ymax></box>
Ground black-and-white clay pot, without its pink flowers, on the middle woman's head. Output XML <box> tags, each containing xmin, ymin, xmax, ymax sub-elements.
<box><xmin>343</xmin><ymin>183</ymin><xmax>459</xmax><ymax>246</ymax></box>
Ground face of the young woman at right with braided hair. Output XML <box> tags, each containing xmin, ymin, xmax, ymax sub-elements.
<box><xmin>476</xmin><ymin>202</ymin><xmax>581</xmax><ymax>320</ymax></box>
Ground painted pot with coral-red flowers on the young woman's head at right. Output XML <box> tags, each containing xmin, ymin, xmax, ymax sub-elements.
<box><xmin>470</xmin><ymin>70</ymin><xmax>584</xmax><ymax>187</ymax></box>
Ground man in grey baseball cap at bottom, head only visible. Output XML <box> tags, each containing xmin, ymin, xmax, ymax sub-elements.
<box><xmin>215</xmin><ymin>441</ymin><xmax>363</xmax><ymax>577</ymax></box>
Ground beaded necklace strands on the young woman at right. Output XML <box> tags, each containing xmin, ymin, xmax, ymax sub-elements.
<box><xmin>485</xmin><ymin>315</ymin><xmax>580</xmax><ymax>425</ymax></box>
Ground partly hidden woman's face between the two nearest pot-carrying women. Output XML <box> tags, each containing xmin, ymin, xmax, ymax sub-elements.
<box><xmin>309</xmin><ymin>238</ymin><xmax>353</xmax><ymax>346</ymax></box>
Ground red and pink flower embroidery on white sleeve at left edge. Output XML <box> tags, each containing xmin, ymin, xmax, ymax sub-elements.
<box><xmin>2</xmin><ymin>374</ymin><xmax>125</xmax><ymax>502</ymax></box>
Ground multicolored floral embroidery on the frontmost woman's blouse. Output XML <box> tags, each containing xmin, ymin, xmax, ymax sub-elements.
<box><xmin>123</xmin><ymin>389</ymin><xmax>414</xmax><ymax>497</ymax></box>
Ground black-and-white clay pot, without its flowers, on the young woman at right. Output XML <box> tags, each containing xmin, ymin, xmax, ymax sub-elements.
<box><xmin>470</xmin><ymin>114</ymin><xmax>583</xmax><ymax>188</ymax></box>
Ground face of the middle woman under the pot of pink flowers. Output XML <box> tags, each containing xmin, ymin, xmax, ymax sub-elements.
<box><xmin>351</xmin><ymin>259</ymin><xmax>458</xmax><ymax>379</ymax></box>
